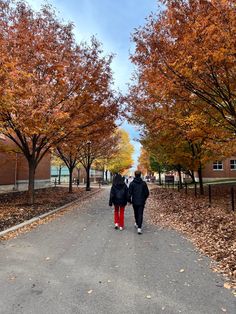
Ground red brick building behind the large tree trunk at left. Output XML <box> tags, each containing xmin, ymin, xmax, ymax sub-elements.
<box><xmin>0</xmin><ymin>136</ymin><xmax>51</xmax><ymax>191</ymax></box>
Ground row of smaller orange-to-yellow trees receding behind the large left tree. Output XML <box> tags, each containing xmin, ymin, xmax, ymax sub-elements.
<box><xmin>53</xmin><ymin>128</ymin><xmax>134</xmax><ymax>192</ymax></box>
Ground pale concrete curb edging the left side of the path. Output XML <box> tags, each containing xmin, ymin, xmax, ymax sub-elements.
<box><xmin>0</xmin><ymin>189</ymin><xmax>102</xmax><ymax>237</ymax></box>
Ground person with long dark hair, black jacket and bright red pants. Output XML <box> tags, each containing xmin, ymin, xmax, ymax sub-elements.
<box><xmin>109</xmin><ymin>174</ymin><xmax>128</xmax><ymax>230</ymax></box>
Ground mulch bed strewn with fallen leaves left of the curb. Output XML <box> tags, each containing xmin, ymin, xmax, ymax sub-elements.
<box><xmin>0</xmin><ymin>187</ymin><xmax>96</xmax><ymax>231</ymax></box>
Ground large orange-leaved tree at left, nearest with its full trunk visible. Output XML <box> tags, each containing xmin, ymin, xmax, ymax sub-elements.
<box><xmin>0</xmin><ymin>0</ymin><xmax>133</xmax><ymax>203</ymax></box>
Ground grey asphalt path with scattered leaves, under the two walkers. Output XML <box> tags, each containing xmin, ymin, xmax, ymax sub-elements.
<box><xmin>0</xmin><ymin>188</ymin><xmax>236</xmax><ymax>314</ymax></box>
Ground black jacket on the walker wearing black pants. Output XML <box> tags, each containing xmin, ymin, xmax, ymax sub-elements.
<box><xmin>129</xmin><ymin>178</ymin><xmax>149</xmax><ymax>206</ymax></box>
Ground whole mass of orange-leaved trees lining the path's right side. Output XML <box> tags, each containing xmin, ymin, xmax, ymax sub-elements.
<box><xmin>128</xmin><ymin>0</ymin><xmax>236</xmax><ymax>193</ymax></box>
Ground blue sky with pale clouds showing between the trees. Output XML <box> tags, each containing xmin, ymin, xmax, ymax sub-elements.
<box><xmin>27</xmin><ymin>0</ymin><xmax>158</xmax><ymax>170</ymax></box>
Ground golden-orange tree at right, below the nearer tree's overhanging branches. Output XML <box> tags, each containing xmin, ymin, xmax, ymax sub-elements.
<box><xmin>129</xmin><ymin>76</ymin><xmax>227</xmax><ymax>193</ymax></box>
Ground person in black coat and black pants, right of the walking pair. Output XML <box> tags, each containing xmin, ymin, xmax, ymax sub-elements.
<box><xmin>129</xmin><ymin>170</ymin><xmax>149</xmax><ymax>234</ymax></box>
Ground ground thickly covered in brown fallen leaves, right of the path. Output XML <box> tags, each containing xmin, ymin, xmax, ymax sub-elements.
<box><xmin>146</xmin><ymin>188</ymin><xmax>236</xmax><ymax>294</ymax></box>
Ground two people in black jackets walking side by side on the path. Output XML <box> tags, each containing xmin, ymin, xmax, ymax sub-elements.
<box><xmin>109</xmin><ymin>170</ymin><xmax>149</xmax><ymax>234</ymax></box>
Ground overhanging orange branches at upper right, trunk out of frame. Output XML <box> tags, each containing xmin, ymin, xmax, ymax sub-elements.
<box><xmin>132</xmin><ymin>0</ymin><xmax>236</xmax><ymax>135</ymax></box>
